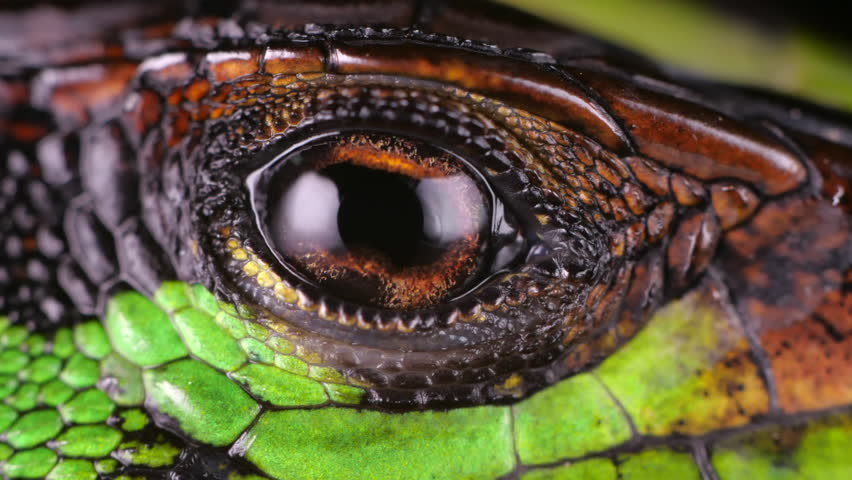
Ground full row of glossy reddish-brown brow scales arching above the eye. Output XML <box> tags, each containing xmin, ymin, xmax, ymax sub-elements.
<box><xmin>31</xmin><ymin>32</ymin><xmax>807</xmax><ymax>202</ymax></box>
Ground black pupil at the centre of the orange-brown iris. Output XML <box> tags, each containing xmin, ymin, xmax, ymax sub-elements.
<box><xmin>330</xmin><ymin>163</ymin><xmax>434</xmax><ymax>267</ymax></box>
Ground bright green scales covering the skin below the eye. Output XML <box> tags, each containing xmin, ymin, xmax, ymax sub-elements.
<box><xmin>0</xmin><ymin>282</ymin><xmax>852</xmax><ymax>479</ymax></box>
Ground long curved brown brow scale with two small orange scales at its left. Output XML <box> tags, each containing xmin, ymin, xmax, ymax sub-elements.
<box><xmin>191</xmin><ymin>38</ymin><xmax>629</xmax><ymax>152</ymax></box>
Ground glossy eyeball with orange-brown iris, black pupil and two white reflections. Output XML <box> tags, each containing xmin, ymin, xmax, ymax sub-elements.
<box><xmin>249</xmin><ymin>132</ymin><xmax>525</xmax><ymax>310</ymax></box>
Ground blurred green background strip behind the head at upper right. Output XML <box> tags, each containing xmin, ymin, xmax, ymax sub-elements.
<box><xmin>500</xmin><ymin>0</ymin><xmax>852</xmax><ymax>111</ymax></box>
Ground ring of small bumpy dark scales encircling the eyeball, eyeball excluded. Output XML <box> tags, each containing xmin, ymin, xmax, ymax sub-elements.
<box><xmin>171</xmin><ymin>69</ymin><xmax>611</xmax><ymax>409</ymax></box>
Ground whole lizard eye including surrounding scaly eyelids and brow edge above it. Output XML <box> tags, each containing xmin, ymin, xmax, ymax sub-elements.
<box><xmin>133</xmin><ymin>39</ymin><xmax>624</xmax><ymax>404</ymax></box>
